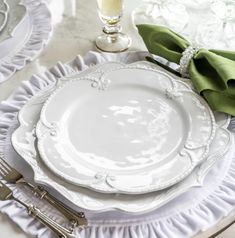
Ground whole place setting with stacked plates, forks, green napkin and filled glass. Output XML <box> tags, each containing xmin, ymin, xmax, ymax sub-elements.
<box><xmin>0</xmin><ymin>0</ymin><xmax>235</xmax><ymax>238</ymax></box>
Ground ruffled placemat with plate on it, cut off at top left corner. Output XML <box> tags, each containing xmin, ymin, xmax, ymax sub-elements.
<box><xmin>0</xmin><ymin>0</ymin><xmax>52</xmax><ymax>83</ymax></box>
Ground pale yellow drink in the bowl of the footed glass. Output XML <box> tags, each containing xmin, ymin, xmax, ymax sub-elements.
<box><xmin>97</xmin><ymin>0</ymin><xmax>122</xmax><ymax>17</ymax></box>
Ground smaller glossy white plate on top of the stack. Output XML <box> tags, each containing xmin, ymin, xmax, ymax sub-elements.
<box><xmin>36</xmin><ymin>64</ymin><xmax>215</xmax><ymax>194</ymax></box>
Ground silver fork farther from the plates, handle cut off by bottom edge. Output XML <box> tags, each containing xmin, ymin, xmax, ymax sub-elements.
<box><xmin>0</xmin><ymin>181</ymin><xmax>75</xmax><ymax>238</ymax></box>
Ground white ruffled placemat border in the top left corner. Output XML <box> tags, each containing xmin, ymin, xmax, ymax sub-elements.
<box><xmin>0</xmin><ymin>0</ymin><xmax>52</xmax><ymax>83</ymax></box>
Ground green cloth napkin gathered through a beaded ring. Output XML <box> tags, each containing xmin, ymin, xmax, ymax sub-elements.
<box><xmin>137</xmin><ymin>24</ymin><xmax>235</xmax><ymax>116</ymax></box>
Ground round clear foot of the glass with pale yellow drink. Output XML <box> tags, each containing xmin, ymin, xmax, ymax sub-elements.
<box><xmin>95</xmin><ymin>32</ymin><xmax>131</xmax><ymax>53</ymax></box>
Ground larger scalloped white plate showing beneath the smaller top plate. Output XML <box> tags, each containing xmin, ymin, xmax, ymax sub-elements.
<box><xmin>12</xmin><ymin>63</ymin><xmax>233</xmax><ymax>214</ymax></box>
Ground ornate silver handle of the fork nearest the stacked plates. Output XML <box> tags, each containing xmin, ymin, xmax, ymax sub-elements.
<box><xmin>28</xmin><ymin>184</ymin><xmax>88</xmax><ymax>229</ymax></box>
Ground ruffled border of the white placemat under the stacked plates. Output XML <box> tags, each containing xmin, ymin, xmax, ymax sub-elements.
<box><xmin>0</xmin><ymin>52</ymin><xmax>235</xmax><ymax>238</ymax></box>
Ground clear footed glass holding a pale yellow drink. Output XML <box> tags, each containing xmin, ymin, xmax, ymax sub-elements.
<box><xmin>95</xmin><ymin>0</ymin><xmax>131</xmax><ymax>52</ymax></box>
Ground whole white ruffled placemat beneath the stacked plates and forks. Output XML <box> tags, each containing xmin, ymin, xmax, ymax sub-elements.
<box><xmin>0</xmin><ymin>52</ymin><xmax>235</xmax><ymax>238</ymax></box>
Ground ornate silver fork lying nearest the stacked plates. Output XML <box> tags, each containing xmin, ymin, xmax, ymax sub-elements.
<box><xmin>0</xmin><ymin>157</ymin><xmax>87</xmax><ymax>229</ymax></box>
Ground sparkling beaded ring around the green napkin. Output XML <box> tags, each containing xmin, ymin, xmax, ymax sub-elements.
<box><xmin>179</xmin><ymin>44</ymin><xmax>201</xmax><ymax>78</ymax></box>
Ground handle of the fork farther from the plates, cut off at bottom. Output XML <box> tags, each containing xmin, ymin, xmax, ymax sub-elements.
<box><xmin>27</xmin><ymin>205</ymin><xmax>75</xmax><ymax>238</ymax></box>
